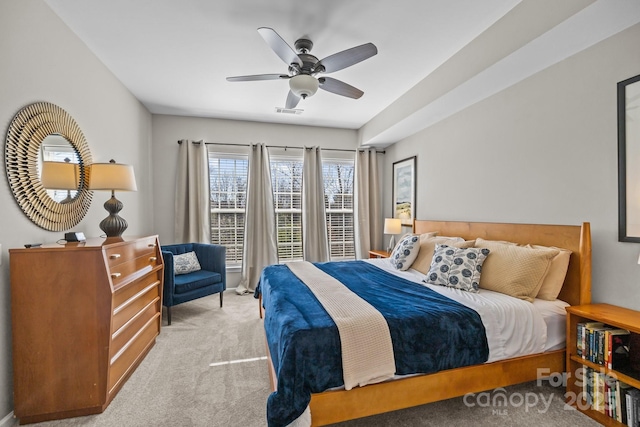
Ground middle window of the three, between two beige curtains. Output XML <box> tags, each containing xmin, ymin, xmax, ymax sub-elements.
<box><xmin>271</xmin><ymin>158</ymin><xmax>302</xmax><ymax>262</ymax></box>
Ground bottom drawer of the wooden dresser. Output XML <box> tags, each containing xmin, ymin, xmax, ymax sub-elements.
<box><xmin>108</xmin><ymin>313</ymin><xmax>160</xmax><ymax>393</ymax></box>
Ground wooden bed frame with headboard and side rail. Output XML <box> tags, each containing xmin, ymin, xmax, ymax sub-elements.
<box><xmin>267</xmin><ymin>220</ymin><xmax>591</xmax><ymax>426</ymax></box>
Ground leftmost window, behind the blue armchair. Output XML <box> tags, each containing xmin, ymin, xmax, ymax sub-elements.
<box><xmin>209</xmin><ymin>153</ymin><xmax>249</xmax><ymax>265</ymax></box>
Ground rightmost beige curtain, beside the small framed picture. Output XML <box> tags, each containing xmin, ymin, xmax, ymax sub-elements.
<box><xmin>353</xmin><ymin>149</ymin><xmax>382</xmax><ymax>259</ymax></box>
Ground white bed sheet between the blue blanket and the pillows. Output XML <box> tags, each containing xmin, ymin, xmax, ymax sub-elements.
<box><xmin>366</xmin><ymin>259</ymin><xmax>568</xmax><ymax>362</ymax></box>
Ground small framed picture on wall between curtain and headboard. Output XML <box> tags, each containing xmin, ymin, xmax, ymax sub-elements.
<box><xmin>393</xmin><ymin>156</ymin><xmax>416</xmax><ymax>226</ymax></box>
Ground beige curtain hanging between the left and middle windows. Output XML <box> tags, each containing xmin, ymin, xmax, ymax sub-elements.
<box><xmin>236</xmin><ymin>144</ymin><xmax>278</xmax><ymax>295</ymax></box>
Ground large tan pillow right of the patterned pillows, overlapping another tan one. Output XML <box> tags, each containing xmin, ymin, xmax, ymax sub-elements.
<box><xmin>476</xmin><ymin>238</ymin><xmax>560</xmax><ymax>302</ymax></box>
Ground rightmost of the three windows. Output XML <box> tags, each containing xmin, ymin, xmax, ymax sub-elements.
<box><xmin>322</xmin><ymin>160</ymin><xmax>356</xmax><ymax>261</ymax></box>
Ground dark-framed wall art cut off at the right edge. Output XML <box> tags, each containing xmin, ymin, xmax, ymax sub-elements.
<box><xmin>618</xmin><ymin>75</ymin><xmax>640</xmax><ymax>243</ymax></box>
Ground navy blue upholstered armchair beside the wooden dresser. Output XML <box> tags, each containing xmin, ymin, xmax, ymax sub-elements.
<box><xmin>162</xmin><ymin>243</ymin><xmax>227</xmax><ymax>325</ymax></box>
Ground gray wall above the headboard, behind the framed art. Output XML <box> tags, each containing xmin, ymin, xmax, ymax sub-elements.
<box><xmin>384</xmin><ymin>25</ymin><xmax>640</xmax><ymax>309</ymax></box>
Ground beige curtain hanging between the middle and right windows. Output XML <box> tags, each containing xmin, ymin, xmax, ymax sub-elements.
<box><xmin>302</xmin><ymin>147</ymin><xmax>329</xmax><ymax>262</ymax></box>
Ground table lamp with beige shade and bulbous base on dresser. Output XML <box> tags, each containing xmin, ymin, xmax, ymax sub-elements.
<box><xmin>89</xmin><ymin>160</ymin><xmax>138</xmax><ymax>237</ymax></box>
